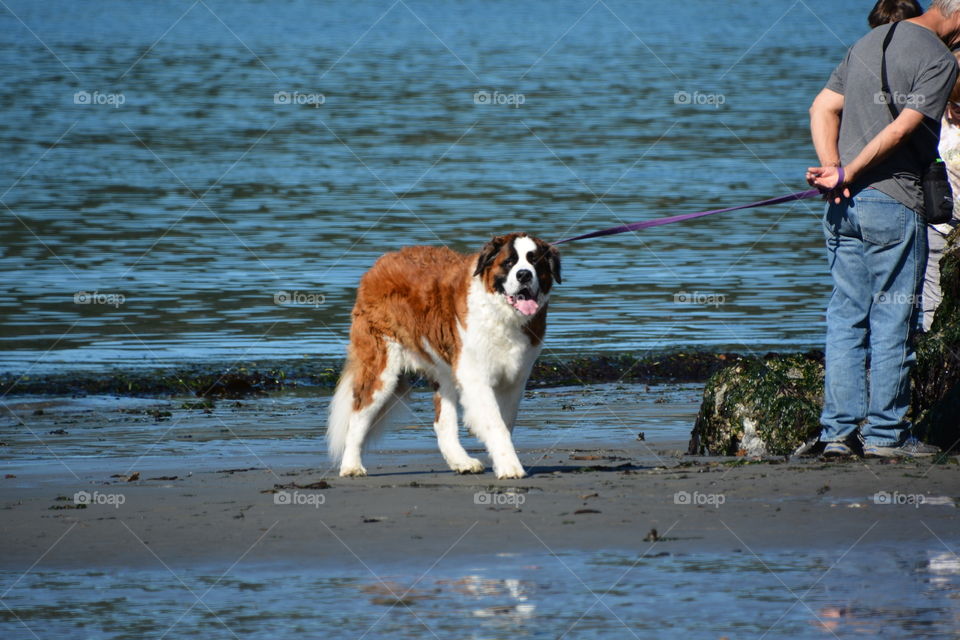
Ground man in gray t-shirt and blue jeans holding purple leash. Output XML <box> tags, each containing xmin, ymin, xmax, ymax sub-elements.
<box><xmin>807</xmin><ymin>0</ymin><xmax>960</xmax><ymax>457</ymax></box>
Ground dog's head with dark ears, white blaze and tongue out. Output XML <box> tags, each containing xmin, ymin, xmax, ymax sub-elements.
<box><xmin>473</xmin><ymin>233</ymin><xmax>561</xmax><ymax>316</ymax></box>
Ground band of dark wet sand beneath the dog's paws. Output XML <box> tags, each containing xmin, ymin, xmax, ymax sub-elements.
<box><xmin>0</xmin><ymin>432</ymin><xmax>960</xmax><ymax>570</ymax></box>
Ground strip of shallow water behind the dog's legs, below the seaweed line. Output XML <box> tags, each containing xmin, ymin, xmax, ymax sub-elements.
<box><xmin>0</xmin><ymin>384</ymin><xmax>702</xmax><ymax>472</ymax></box>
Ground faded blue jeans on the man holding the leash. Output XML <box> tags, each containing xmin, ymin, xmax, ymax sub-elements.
<box><xmin>820</xmin><ymin>189</ymin><xmax>927</xmax><ymax>446</ymax></box>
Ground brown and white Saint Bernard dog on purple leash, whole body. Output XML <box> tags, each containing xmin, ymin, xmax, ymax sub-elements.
<box><xmin>327</xmin><ymin>233</ymin><xmax>560</xmax><ymax>478</ymax></box>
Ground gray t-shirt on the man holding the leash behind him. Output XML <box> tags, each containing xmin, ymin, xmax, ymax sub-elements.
<box><xmin>826</xmin><ymin>22</ymin><xmax>957</xmax><ymax>213</ymax></box>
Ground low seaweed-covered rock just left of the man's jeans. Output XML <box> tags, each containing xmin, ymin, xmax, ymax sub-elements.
<box><xmin>688</xmin><ymin>354</ymin><xmax>823</xmax><ymax>456</ymax></box>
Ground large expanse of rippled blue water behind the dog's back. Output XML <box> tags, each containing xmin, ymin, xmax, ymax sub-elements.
<box><xmin>0</xmin><ymin>0</ymin><xmax>868</xmax><ymax>371</ymax></box>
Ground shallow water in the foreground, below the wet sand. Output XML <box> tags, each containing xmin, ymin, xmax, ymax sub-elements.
<box><xmin>0</xmin><ymin>549</ymin><xmax>960</xmax><ymax>639</ymax></box>
